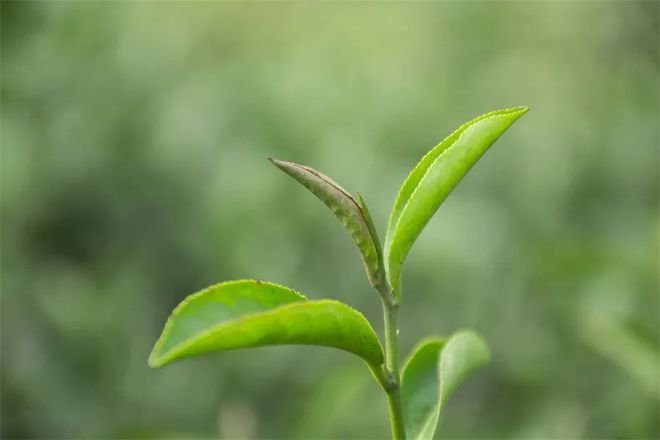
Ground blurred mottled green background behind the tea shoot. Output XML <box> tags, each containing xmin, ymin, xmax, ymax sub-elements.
<box><xmin>1</xmin><ymin>1</ymin><xmax>660</xmax><ymax>439</ymax></box>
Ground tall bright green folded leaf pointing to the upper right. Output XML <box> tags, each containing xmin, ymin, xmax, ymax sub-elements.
<box><xmin>385</xmin><ymin>107</ymin><xmax>527</xmax><ymax>298</ymax></box>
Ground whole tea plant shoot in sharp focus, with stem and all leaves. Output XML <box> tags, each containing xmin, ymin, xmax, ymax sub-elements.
<box><xmin>149</xmin><ymin>107</ymin><xmax>527</xmax><ymax>440</ymax></box>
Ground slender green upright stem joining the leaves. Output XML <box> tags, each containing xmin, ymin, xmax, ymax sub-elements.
<box><xmin>379</xmin><ymin>287</ymin><xmax>406</xmax><ymax>440</ymax></box>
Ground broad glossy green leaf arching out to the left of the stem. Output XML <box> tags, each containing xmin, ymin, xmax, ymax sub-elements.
<box><xmin>149</xmin><ymin>280</ymin><xmax>383</xmax><ymax>367</ymax></box>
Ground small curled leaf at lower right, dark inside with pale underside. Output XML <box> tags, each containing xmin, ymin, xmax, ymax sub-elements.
<box><xmin>401</xmin><ymin>331</ymin><xmax>490</xmax><ymax>440</ymax></box>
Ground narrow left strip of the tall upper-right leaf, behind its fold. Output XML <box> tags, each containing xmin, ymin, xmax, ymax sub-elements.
<box><xmin>384</xmin><ymin>106</ymin><xmax>529</xmax><ymax>295</ymax></box>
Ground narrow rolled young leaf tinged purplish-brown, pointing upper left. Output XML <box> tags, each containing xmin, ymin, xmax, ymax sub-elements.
<box><xmin>268</xmin><ymin>157</ymin><xmax>384</xmax><ymax>286</ymax></box>
